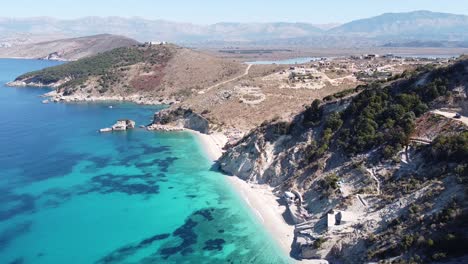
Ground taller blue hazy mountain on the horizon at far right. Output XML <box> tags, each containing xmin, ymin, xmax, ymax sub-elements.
<box><xmin>329</xmin><ymin>11</ymin><xmax>468</xmax><ymax>40</ymax></box>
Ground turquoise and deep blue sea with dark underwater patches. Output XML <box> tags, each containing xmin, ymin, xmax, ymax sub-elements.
<box><xmin>0</xmin><ymin>60</ymin><xmax>289</xmax><ymax>264</ymax></box>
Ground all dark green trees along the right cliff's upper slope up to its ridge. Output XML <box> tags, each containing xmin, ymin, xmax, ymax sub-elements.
<box><xmin>310</xmin><ymin>59</ymin><xmax>465</xmax><ymax>158</ymax></box>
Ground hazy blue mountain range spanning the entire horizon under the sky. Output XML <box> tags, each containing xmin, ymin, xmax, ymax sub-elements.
<box><xmin>0</xmin><ymin>11</ymin><xmax>468</xmax><ymax>47</ymax></box>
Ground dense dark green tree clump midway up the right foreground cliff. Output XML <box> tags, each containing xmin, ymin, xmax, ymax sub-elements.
<box><xmin>340</xmin><ymin>71</ymin><xmax>454</xmax><ymax>158</ymax></box>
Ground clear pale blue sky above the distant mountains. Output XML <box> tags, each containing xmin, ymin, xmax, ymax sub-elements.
<box><xmin>0</xmin><ymin>0</ymin><xmax>468</xmax><ymax>24</ymax></box>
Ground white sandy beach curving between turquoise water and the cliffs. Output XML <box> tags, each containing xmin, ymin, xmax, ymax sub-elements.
<box><xmin>193</xmin><ymin>132</ymin><xmax>294</xmax><ymax>256</ymax></box>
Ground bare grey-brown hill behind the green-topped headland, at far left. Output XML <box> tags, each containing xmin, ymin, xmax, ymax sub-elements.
<box><xmin>0</xmin><ymin>34</ymin><xmax>138</xmax><ymax>61</ymax></box>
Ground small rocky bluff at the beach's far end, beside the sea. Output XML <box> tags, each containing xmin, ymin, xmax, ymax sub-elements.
<box><xmin>153</xmin><ymin>107</ymin><xmax>210</xmax><ymax>134</ymax></box>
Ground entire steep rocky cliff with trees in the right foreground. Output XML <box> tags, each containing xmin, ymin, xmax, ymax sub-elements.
<box><xmin>219</xmin><ymin>60</ymin><xmax>468</xmax><ymax>263</ymax></box>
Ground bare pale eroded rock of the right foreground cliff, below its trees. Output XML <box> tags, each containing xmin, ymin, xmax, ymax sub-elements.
<box><xmin>219</xmin><ymin>104</ymin><xmax>468</xmax><ymax>263</ymax></box>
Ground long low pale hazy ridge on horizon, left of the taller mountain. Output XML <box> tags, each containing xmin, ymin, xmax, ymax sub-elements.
<box><xmin>0</xmin><ymin>17</ymin><xmax>322</xmax><ymax>42</ymax></box>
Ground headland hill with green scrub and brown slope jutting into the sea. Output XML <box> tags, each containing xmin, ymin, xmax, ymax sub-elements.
<box><xmin>10</xmin><ymin>44</ymin><xmax>246</xmax><ymax>103</ymax></box>
